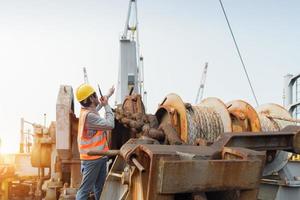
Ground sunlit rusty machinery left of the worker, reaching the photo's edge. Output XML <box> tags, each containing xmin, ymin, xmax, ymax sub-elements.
<box><xmin>0</xmin><ymin>86</ymin><xmax>81</xmax><ymax>200</ymax></box>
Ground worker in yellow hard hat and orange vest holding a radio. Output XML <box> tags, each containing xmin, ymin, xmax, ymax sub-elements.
<box><xmin>76</xmin><ymin>83</ymin><xmax>114</xmax><ymax>200</ymax></box>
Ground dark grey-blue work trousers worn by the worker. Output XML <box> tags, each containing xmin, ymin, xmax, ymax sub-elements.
<box><xmin>76</xmin><ymin>156</ymin><xmax>107</xmax><ymax>200</ymax></box>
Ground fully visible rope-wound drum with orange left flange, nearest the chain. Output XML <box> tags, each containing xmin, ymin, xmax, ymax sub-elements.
<box><xmin>156</xmin><ymin>94</ymin><xmax>232</xmax><ymax>144</ymax></box>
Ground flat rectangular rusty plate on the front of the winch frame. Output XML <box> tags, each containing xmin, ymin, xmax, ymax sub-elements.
<box><xmin>159</xmin><ymin>160</ymin><xmax>263</xmax><ymax>194</ymax></box>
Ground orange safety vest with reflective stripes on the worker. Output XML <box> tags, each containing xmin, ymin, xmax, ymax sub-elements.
<box><xmin>77</xmin><ymin>108</ymin><xmax>109</xmax><ymax>160</ymax></box>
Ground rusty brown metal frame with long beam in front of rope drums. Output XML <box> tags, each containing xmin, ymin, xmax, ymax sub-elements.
<box><xmin>101</xmin><ymin>127</ymin><xmax>300</xmax><ymax>200</ymax></box>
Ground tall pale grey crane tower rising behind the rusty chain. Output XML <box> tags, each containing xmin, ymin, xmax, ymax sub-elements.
<box><xmin>116</xmin><ymin>0</ymin><xmax>147</xmax><ymax>107</ymax></box>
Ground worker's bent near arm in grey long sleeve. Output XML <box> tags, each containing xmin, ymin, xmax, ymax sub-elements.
<box><xmin>87</xmin><ymin>105</ymin><xmax>115</xmax><ymax>130</ymax></box>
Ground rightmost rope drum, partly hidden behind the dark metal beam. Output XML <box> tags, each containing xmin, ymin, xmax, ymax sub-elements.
<box><xmin>256</xmin><ymin>103</ymin><xmax>292</xmax><ymax>176</ymax></box>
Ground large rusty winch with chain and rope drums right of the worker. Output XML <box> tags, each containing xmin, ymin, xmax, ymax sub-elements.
<box><xmin>90</xmin><ymin>94</ymin><xmax>299</xmax><ymax>200</ymax></box>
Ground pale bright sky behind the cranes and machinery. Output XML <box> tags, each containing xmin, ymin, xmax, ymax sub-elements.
<box><xmin>0</xmin><ymin>0</ymin><xmax>300</xmax><ymax>152</ymax></box>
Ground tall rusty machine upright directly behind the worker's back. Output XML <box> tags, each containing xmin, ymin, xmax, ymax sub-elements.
<box><xmin>50</xmin><ymin>85</ymin><xmax>81</xmax><ymax>198</ymax></box>
